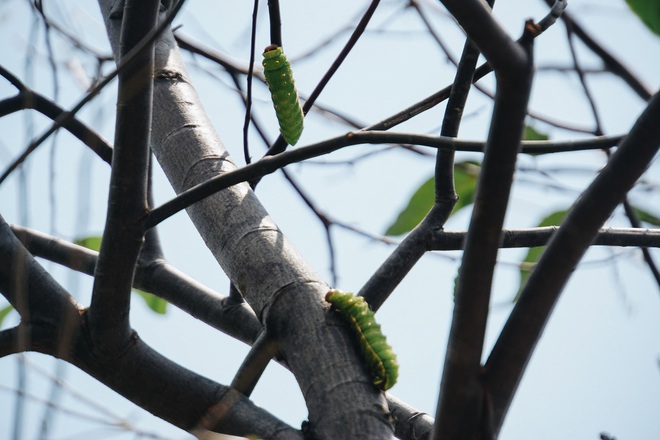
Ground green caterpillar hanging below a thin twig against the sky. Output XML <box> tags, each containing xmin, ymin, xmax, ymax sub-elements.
<box><xmin>263</xmin><ymin>45</ymin><xmax>303</xmax><ymax>145</ymax></box>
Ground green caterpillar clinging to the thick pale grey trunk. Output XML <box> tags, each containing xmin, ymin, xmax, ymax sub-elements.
<box><xmin>325</xmin><ymin>290</ymin><xmax>399</xmax><ymax>391</ymax></box>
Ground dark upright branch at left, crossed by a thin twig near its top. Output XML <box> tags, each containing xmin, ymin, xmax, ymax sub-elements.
<box><xmin>88</xmin><ymin>0</ymin><xmax>160</xmax><ymax>352</ymax></box>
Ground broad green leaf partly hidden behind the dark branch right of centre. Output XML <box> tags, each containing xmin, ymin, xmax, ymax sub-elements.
<box><xmin>385</xmin><ymin>161</ymin><xmax>480</xmax><ymax>235</ymax></box>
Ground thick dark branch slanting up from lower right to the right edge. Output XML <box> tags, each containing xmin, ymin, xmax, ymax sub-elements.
<box><xmin>484</xmin><ymin>94</ymin><xmax>660</xmax><ymax>432</ymax></box>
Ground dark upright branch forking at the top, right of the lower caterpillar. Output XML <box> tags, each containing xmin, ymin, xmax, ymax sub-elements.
<box><xmin>434</xmin><ymin>1</ymin><xmax>534</xmax><ymax>440</ymax></box>
